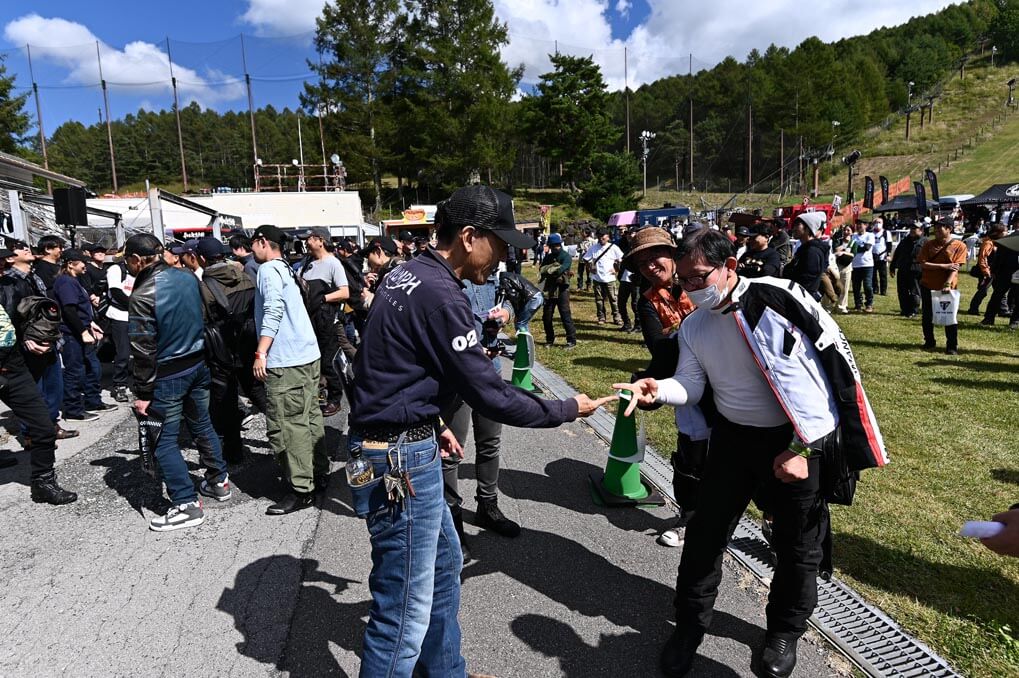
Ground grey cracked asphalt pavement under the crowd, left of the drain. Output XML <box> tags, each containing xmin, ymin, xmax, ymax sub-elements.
<box><xmin>0</xmin><ymin>389</ymin><xmax>849</xmax><ymax>678</ymax></box>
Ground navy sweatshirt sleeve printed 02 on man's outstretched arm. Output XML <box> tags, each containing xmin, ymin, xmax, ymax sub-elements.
<box><xmin>423</xmin><ymin>298</ymin><xmax>578</xmax><ymax>428</ymax></box>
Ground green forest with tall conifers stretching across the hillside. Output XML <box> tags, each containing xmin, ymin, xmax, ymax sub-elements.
<box><xmin>0</xmin><ymin>0</ymin><xmax>1019</xmax><ymax>210</ymax></box>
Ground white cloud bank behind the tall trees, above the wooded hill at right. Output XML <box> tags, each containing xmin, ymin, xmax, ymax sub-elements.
<box><xmin>234</xmin><ymin>0</ymin><xmax>958</xmax><ymax>90</ymax></box>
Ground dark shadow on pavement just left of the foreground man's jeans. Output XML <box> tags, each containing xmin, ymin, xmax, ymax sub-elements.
<box><xmin>216</xmin><ymin>555</ymin><xmax>371</xmax><ymax>678</ymax></box>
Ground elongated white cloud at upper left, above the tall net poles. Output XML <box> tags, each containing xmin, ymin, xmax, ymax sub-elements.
<box><xmin>4</xmin><ymin>13</ymin><xmax>245</xmax><ymax>106</ymax></box>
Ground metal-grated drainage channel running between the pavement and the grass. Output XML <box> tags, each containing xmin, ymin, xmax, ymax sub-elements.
<box><xmin>532</xmin><ymin>363</ymin><xmax>959</xmax><ymax>678</ymax></box>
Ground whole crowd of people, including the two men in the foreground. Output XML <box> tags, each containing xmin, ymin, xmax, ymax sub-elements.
<box><xmin>0</xmin><ymin>190</ymin><xmax>1019</xmax><ymax>676</ymax></box>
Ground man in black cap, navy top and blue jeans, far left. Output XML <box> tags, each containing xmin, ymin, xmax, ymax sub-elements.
<box><xmin>53</xmin><ymin>250</ymin><xmax>116</xmax><ymax>421</ymax></box>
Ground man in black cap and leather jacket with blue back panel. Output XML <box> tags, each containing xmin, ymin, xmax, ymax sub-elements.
<box><xmin>124</xmin><ymin>233</ymin><xmax>232</xmax><ymax>532</ymax></box>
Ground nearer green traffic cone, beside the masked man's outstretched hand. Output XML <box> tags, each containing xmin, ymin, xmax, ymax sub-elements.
<box><xmin>591</xmin><ymin>390</ymin><xmax>664</xmax><ymax>506</ymax></box>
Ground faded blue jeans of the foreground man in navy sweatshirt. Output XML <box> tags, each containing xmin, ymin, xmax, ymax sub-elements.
<box><xmin>350</xmin><ymin>431</ymin><xmax>467</xmax><ymax>678</ymax></box>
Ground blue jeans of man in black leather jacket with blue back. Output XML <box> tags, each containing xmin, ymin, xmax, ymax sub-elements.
<box><xmin>149</xmin><ymin>363</ymin><xmax>226</xmax><ymax>505</ymax></box>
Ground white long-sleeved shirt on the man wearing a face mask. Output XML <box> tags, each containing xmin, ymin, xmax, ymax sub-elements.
<box><xmin>658</xmin><ymin>309</ymin><xmax>789</xmax><ymax>428</ymax></box>
